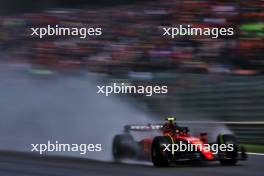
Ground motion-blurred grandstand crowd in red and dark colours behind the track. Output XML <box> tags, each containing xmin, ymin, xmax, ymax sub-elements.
<box><xmin>0</xmin><ymin>0</ymin><xmax>264</xmax><ymax>74</ymax></box>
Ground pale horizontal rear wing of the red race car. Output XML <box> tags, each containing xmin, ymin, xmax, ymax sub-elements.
<box><xmin>124</xmin><ymin>124</ymin><xmax>163</xmax><ymax>132</ymax></box>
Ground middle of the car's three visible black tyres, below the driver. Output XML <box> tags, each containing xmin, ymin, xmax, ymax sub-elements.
<box><xmin>151</xmin><ymin>136</ymin><xmax>172</xmax><ymax>167</ymax></box>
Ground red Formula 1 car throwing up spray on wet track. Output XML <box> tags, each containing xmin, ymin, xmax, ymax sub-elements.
<box><xmin>112</xmin><ymin>118</ymin><xmax>247</xmax><ymax>167</ymax></box>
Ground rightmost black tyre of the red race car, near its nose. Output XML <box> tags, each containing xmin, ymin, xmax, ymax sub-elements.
<box><xmin>217</xmin><ymin>134</ymin><xmax>238</xmax><ymax>165</ymax></box>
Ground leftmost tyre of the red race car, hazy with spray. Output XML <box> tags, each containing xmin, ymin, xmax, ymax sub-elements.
<box><xmin>112</xmin><ymin>134</ymin><xmax>135</xmax><ymax>161</ymax></box>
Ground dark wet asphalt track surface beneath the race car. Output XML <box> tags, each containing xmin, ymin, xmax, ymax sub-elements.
<box><xmin>0</xmin><ymin>153</ymin><xmax>264</xmax><ymax>176</ymax></box>
